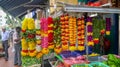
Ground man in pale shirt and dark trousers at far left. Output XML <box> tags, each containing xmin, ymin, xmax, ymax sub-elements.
<box><xmin>1</xmin><ymin>28</ymin><xmax>9</xmax><ymax>61</ymax></box>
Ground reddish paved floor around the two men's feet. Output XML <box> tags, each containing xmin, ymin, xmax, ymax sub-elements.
<box><xmin>0</xmin><ymin>47</ymin><xmax>18</xmax><ymax>67</ymax></box>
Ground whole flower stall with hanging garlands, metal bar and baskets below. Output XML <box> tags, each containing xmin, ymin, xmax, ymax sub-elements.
<box><xmin>21</xmin><ymin>3</ymin><xmax>120</xmax><ymax>67</ymax></box>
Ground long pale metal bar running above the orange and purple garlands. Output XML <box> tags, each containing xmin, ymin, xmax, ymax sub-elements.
<box><xmin>64</xmin><ymin>6</ymin><xmax>120</xmax><ymax>13</ymax></box>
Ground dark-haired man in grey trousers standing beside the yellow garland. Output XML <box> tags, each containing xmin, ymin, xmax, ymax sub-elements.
<box><xmin>13</xmin><ymin>27</ymin><xmax>22</xmax><ymax>66</ymax></box>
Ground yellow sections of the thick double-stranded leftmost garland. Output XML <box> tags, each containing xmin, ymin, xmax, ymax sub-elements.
<box><xmin>21</xmin><ymin>18</ymin><xmax>36</xmax><ymax>57</ymax></box>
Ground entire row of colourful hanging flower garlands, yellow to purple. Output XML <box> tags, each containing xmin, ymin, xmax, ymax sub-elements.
<box><xmin>21</xmin><ymin>14</ymin><xmax>111</xmax><ymax>58</ymax></box>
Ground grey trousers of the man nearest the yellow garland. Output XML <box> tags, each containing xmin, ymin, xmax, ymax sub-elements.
<box><xmin>14</xmin><ymin>44</ymin><xmax>22</xmax><ymax>66</ymax></box>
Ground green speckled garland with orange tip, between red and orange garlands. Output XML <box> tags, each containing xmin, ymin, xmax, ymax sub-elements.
<box><xmin>54</xmin><ymin>18</ymin><xmax>61</xmax><ymax>54</ymax></box>
